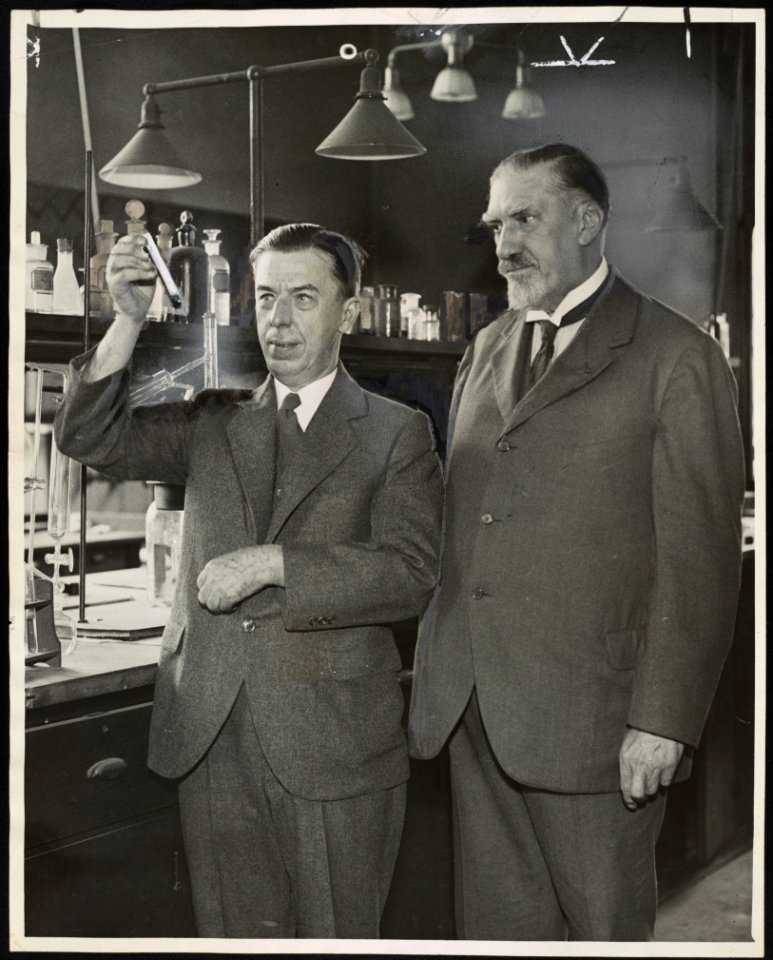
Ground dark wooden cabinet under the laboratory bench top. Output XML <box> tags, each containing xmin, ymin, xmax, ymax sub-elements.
<box><xmin>24</xmin><ymin>688</ymin><xmax>196</xmax><ymax>937</ymax></box>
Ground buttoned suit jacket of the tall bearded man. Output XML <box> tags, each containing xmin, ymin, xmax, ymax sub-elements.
<box><xmin>409</xmin><ymin>266</ymin><xmax>745</xmax><ymax>793</ymax></box>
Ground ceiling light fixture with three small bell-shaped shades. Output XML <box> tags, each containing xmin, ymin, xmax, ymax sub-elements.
<box><xmin>383</xmin><ymin>27</ymin><xmax>545</xmax><ymax>120</ymax></box>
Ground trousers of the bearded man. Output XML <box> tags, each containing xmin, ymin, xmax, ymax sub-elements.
<box><xmin>450</xmin><ymin>694</ymin><xmax>665</xmax><ymax>941</ymax></box>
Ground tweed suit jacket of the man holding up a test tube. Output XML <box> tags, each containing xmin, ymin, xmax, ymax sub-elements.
<box><xmin>55</xmin><ymin>354</ymin><xmax>442</xmax><ymax>800</ymax></box>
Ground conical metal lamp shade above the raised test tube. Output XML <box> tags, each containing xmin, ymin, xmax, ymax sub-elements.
<box><xmin>99</xmin><ymin>97</ymin><xmax>201</xmax><ymax>190</ymax></box>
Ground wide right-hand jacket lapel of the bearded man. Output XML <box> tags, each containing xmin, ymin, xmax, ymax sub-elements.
<box><xmin>504</xmin><ymin>277</ymin><xmax>639</xmax><ymax>433</ymax></box>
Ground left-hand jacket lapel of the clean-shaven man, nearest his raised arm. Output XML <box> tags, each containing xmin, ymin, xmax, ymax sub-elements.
<box><xmin>226</xmin><ymin>377</ymin><xmax>276</xmax><ymax>541</ymax></box>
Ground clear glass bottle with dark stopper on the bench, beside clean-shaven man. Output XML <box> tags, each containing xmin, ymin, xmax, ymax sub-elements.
<box><xmin>145</xmin><ymin>484</ymin><xmax>184</xmax><ymax>607</ymax></box>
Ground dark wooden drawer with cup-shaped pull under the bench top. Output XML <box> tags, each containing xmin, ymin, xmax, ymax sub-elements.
<box><xmin>25</xmin><ymin>703</ymin><xmax>176</xmax><ymax>850</ymax></box>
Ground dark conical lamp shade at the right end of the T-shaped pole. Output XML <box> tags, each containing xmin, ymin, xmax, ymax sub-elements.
<box><xmin>315</xmin><ymin>67</ymin><xmax>427</xmax><ymax>160</ymax></box>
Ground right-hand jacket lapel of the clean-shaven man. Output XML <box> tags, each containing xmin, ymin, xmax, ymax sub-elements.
<box><xmin>266</xmin><ymin>364</ymin><xmax>368</xmax><ymax>543</ymax></box>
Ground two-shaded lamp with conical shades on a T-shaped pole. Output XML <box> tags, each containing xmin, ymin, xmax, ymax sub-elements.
<box><xmin>99</xmin><ymin>43</ymin><xmax>426</xmax><ymax>246</ymax></box>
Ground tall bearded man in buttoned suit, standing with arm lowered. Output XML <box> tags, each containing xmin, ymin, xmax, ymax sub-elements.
<box><xmin>410</xmin><ymin>144</ymin><xmax>744</xmax><ymax>940</ymax></box>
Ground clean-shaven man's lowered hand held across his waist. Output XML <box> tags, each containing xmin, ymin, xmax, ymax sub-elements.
<box><xmin>196</xmin><ymin>544</ymin><xmax>284</xmax><ymax>613</ymax></box>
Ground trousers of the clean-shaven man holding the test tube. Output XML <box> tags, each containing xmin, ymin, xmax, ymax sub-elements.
<box><xmin>179</xmin><ymin>689</ymin><xmax>406</xmax><ymax>939</ymax></box>
